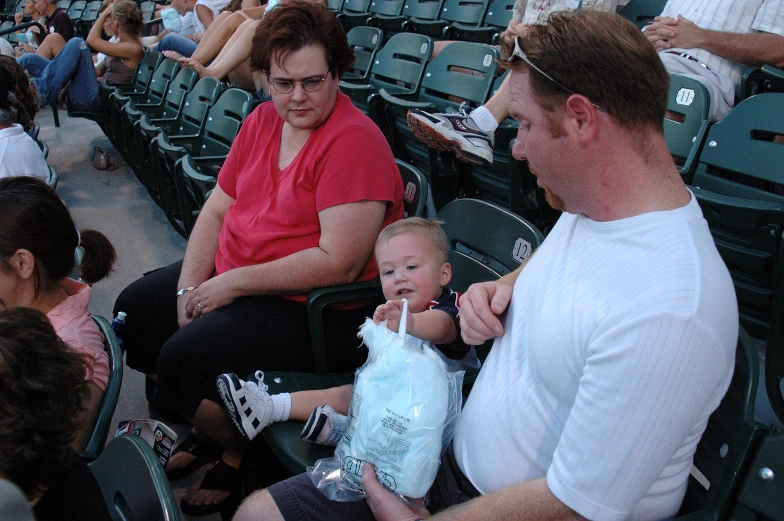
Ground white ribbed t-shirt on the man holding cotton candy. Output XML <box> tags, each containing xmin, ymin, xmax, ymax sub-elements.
<box><xmin>454</xmin><ymin>195</ymin><xmax>738</xmax><ymax>521</ymax></box>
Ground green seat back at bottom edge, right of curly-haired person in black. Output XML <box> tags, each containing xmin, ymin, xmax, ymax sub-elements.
<box><xmin>90</xmin><ymin>435</ymin><xmax>182</xmax><ymax>521</ymax></box>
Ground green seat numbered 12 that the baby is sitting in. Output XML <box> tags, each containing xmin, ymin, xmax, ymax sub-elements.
<box><xmin>260</xmin><ymin>199</ymin><xmax>544</xmax><ymax>474</ymax></box>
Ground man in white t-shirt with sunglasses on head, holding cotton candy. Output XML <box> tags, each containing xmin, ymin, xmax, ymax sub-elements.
<box><xmin>235</xmin><ymin>10</ymin><xmax>738</xmax><ymax>521</ymax></box>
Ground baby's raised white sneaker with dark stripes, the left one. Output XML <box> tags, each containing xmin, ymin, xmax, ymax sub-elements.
<box><xmin>216</xmin><ymin>371</ymin><xmax>272</xmax><ymax>440</ymax></box>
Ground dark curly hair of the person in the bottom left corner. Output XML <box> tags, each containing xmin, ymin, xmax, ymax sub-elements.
<box><xmin>0</xmin><ymin>308</ymin><xmax>88</xmax><ymax>498</ymax></box>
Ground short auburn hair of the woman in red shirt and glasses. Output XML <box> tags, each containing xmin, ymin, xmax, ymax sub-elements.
<box><xmin>250</xmin><ymin>0</ymin><xmax>354</xmax><ymax>77</ymax></box>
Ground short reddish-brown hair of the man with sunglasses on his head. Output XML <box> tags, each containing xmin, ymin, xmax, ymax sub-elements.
<box><xmin>503</xmin><ymin>9</ymin><xmax>670</xmax><ymax>132</ymax></box>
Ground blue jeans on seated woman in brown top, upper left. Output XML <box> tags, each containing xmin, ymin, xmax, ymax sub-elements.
<box><xmin>17</xmin><ymin>38</ymin><xmax>101</xmax><ymax>112</ymax></box>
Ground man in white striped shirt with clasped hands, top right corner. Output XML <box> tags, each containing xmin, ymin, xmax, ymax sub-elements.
<box><xmin>645</xmin><ymin>0</ymin><xmax>784</xmax><ymax>121</ymax></box>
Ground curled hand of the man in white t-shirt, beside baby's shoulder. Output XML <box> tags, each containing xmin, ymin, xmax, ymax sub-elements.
<box><xmin>460</xmin><ymin>280</ymin><xmax>514</xmax><ymax>346</ymax></box>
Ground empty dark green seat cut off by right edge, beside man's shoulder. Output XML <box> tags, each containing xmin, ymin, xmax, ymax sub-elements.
<box><xmin>692</xmin><ymin>93</ymin><xmax>784</xmax><ymax>339</ymax></box>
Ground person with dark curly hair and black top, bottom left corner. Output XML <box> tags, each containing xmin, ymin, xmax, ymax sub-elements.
<box><xmin>0</xmin><ymin>308</ymin><xmax>111</xmax><ymax>521</ymax></box>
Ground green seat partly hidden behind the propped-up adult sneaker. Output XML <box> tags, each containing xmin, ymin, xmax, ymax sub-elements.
<box><xmin>378</xmin><ymin>42</ymin><xmax>498</xmax><ymax>210</ymax></box>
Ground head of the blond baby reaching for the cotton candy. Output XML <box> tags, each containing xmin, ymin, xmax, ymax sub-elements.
<box><xmin>376</xmin><ymin>217</ymin><xmax>452</xmax><ymax>313</ymax></box>
